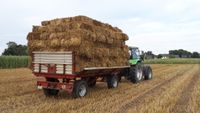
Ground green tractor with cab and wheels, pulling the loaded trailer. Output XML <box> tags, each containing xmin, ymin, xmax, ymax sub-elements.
<box><xmin>122</xmin><ymin>47</ymin><xmax>153</xmax><ymax>83</ymax></box>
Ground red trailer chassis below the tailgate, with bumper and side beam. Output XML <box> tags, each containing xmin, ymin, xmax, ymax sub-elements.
<box><xmin>33</xmin><ymin>66</ymin><xmax>129</xmax><ymax>94</ymax></box>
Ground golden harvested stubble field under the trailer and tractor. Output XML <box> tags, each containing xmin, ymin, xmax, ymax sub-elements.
<box><xmin>0</xmin><ymin>64</ymin><xmax>200</xmax><ymax>113</ymax></box>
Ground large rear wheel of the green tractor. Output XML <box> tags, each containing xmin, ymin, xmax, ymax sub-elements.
<box><xmin>129</xmin><ymin>65</ymin><xmax>143</xmax><ymax>83</ymax></box>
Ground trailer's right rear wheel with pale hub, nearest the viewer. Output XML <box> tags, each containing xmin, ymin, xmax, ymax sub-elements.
<box><xmin>72</xmin><ymin>80</ymin><xmax>88</xmax><ymax>98</ymax></box>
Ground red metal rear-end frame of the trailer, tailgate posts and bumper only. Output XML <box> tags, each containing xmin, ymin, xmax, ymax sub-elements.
<box><xmin>31</xmin><ymin>52</ymin><xmax>80</xmax><ymax>93</ymax></box>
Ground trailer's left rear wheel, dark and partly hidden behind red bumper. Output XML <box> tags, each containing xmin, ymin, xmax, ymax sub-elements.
<box><xmin>43</xmin><ymin>78</ymin><xmax>59</xmax><ymax>97</ymax></box>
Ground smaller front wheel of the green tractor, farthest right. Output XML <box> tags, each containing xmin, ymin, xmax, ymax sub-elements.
<box><xmin>143</xmin><ymin>66</ymin><xmax>153</xmax><ymax>80</ymax></box>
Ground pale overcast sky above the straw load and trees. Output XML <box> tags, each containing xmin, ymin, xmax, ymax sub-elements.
<box><xmin>0</xmin><ymin>0</ymin><xmax>200</xmax><ymax>54</ymax></box>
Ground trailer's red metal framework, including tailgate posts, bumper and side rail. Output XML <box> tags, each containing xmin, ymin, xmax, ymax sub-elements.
<box><xmin>31</xmin><ymin>52</ymin><xmax>127</xmax><ymax>93</ymax></box>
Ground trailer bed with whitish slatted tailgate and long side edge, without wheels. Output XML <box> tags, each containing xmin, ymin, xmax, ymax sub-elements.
<box><xmin>32</xmin><ymin>51</ymin><xmax>130</xmax><ymax>78</ymax></box>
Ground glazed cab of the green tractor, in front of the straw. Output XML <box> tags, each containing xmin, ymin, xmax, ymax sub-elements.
<box><xmin>129</xmin><ymin>47</ymin><xmax>142</xmax><ymax>65</ymax></box>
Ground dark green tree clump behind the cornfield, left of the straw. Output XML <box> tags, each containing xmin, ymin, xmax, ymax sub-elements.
<box><xmin>2</xmin><ymin>42</ymin><xmax>28</xmax><ymax>56</ymax></box>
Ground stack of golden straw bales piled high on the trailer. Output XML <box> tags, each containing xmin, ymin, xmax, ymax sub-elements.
<box><xmin>27</xmin><ymin>16</ymin><xmax>129</xmax><ymax>70</ymax></box>
